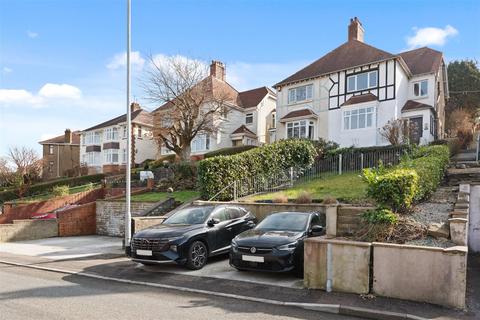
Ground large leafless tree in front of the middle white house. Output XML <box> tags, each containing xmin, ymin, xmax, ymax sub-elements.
<box><xmin>141</xmin><ymin>57</ymin><xmax>234</xmax><ymax>161</ymax></box>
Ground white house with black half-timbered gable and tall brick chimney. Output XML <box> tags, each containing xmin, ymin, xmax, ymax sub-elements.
<box><xmin>274</xmin><ymin>17</ymin><xmax>448</xmax><ymax>147</ymax></box>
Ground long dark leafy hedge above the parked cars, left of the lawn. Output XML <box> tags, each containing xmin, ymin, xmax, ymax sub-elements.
<box><xmin>198</xmin><ymin>139</ymin><xmax>316</xmax><ymax>200</ymax></box>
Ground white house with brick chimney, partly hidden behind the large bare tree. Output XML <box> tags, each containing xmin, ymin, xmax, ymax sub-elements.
<box><xmin>157</xmin><ymin>61</ymin><xmax>276</xmax><ymax>158</ymax></box>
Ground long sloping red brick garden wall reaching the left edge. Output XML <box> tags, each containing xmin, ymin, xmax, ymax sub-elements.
<box><xmin>0</xmin><ymin>189</ymin><xmax>105</xmax><ymax>224</ymax></box>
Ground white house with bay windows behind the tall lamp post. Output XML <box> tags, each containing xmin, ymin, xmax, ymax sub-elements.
<box><xmin>80</xmin><ymin>103</ymin><xmax>158</xmax><ymax>174</ymax></box>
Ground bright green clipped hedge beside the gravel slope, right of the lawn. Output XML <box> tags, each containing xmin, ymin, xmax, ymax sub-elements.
<box><xmin>363</xmin><ymin>145</ymin><xmax>450</xmax><ymax>211</ymax></box>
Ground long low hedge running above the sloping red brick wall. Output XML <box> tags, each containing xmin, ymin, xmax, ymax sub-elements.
<box><xmin>0</xmin><ymin>174</ymin><xmax>105</xmax><ymax>203</ymax></box>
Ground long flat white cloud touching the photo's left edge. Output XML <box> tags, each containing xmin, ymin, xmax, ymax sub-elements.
<box><xmin>0</xmin><ymin>83</ymin><xmax>82</xmax><ymax>108</ymax></box>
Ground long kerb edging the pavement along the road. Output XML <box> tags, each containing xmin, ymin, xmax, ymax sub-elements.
<box><xmin>0</xmin><ymin>260</ymin><xmax>428</xmax><ymax>320</ymax></box>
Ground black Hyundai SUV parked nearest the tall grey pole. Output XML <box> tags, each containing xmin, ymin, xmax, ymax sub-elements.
<box><xmin>126</xmin><ymin>205</ymin><xmax>256</xmax><ymax>270</ymax></box>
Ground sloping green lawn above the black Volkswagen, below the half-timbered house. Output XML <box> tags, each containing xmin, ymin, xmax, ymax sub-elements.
<box><xmin>248</xmin><ymin>173</ymin><xmax>371</xmax><ymax>204</ymax></box>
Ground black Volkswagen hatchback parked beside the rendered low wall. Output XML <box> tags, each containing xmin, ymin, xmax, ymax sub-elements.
<box><xmin>230</xmin><ymin>212</ymin><xmax>324</xmax><ymax>275</ymax></box>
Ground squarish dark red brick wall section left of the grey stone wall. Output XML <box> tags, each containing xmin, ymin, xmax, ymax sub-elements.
<box><xmin>57</xmin><ymin>202</ymin><xmax>97</xmax><ymax>237</ymax></box>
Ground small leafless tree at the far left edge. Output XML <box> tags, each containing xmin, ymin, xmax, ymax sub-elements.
<box><xmin>4</xmin><ymin>147</ymin><xmax>42</xmax><ymax>197</ymax></box>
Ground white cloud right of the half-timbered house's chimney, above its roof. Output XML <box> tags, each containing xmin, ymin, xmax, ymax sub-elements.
<box><xmin>407</xmin><ymin>25</ymin><xmax>458</xmax><ymax>48</ymax></box>
